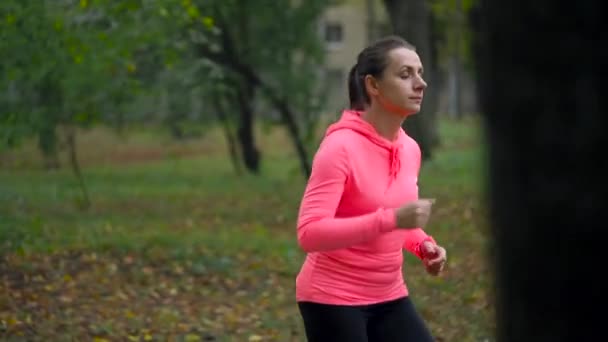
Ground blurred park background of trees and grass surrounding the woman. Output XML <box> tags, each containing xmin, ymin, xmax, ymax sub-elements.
<box><xmin>0</xmin><ymin>0</ymin><xmax>494</xmax><ymax>342</ymax></box>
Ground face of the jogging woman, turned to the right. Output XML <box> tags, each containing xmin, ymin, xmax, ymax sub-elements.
<box><xmin>368</xmin><ymin>48</ymin><xmax>426</xmax><ymax>116</ymax></box>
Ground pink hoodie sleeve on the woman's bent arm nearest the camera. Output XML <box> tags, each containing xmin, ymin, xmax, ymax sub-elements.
<box><xmin>297</xmin><ymin>134</ymin><xmax>396</xmax><ymax>252</ymax></box>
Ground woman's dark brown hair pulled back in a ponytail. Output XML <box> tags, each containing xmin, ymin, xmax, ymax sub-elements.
<box><xmin>348</xmin><ymin>35</ymin><xmax>416</xmax><ymax>110</ymax></box>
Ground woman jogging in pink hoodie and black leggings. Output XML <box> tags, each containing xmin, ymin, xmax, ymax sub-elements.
<box><xmin>296</xmin><ymin>36</ymin><xmax>446</xmax><ymax>342</ymax></box>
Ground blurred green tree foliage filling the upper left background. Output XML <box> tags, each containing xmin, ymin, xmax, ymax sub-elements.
<box><xmin>0</xmin><ymin>0</ymin><xmax>327</xmax><ymax>148</ymax></box>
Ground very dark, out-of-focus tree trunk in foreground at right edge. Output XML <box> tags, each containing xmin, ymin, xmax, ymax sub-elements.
<box><xmin>472</xmin><ymin>0</ymin><xmax>608</xmax><ymax>342</ymax></box>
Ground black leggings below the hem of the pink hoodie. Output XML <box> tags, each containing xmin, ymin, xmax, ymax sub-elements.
<box><xmin>298</xmin><ymin>297</ymin><xmax>434</xmax><ymax>342</ymax></box>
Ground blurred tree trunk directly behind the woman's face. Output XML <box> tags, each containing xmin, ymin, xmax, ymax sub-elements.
<box><xmin>384</xmin><ymin>0</ymin><xmax>439</xmax><ymax>159</ymax></box>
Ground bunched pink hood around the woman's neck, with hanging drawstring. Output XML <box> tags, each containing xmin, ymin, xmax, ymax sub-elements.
<box><xmin>325</xmin><ymin>110</ymin><xmax>403</xmax><ymax>179</ymax></box>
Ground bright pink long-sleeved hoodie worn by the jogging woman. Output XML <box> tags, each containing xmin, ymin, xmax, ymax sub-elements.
<box><xmin>296</xmin><ymin>110</ymin><xmax>434</xmax><ymax>305</ymax></box>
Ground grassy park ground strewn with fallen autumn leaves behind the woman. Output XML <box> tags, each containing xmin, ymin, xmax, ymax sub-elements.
<box><xmin>0</xmin><ymin>120</ymin><xmax>494</xmax><ymax>342</ymax></box>
